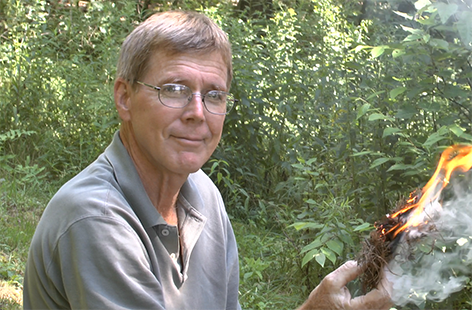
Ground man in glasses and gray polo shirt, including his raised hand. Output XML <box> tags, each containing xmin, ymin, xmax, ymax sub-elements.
<box><xmin>24</xmin><ymin>12</ymin><xmax>389</xmax><ymax>310</ymax></box>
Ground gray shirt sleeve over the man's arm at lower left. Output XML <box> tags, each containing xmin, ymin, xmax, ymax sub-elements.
<box><xmin>24</xmin><ymin>216</ymin><xmax>165</xmax><ymax>310</ymax></box>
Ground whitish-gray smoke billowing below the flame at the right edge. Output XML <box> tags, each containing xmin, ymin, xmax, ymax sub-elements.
<box><xmin>387</xmin><ymin>177</ymin><xmax>472</xmax><ymax>306</ymax></box>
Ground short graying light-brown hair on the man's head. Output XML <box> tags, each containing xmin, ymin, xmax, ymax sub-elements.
<box><xmin>117</xmin><ymin>11</ymin><xmax>233</xmax><ymax>88</ymax></box>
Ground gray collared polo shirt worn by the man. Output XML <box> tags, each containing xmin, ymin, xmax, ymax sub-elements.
<box><xmin>23</xmin><ymin>133</ymin><xmax>240</xmax><ymax>310</ymax></box>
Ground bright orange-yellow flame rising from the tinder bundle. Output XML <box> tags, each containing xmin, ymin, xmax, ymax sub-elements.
<box><xmin>390</xmin><ymin>145</ymin><xmax>472</xmax><ymax>237</ymax></box>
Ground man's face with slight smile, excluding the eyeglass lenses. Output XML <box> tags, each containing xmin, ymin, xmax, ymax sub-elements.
<box><xmin>118</xmin><ymin>52</ymin><xmax>228</xmax><ymax>175</ymax></box>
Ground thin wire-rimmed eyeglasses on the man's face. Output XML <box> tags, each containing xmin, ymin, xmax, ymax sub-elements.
<box><xmin>136</xmin><ymin>81</ymin><xmax>238</xmax><ymax>115</ymax></box>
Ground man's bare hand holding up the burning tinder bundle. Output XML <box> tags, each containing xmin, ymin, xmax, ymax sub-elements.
<box><xmin>298</xmin><ymin>261</ymin><xmax>392</xmax><ymax>310</ymax></box>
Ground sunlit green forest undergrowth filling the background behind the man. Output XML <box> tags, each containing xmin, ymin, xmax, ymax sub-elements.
<box><xmin>0</xmin><ymin>0</ymin><xmax>472</xmax><ymax>310</ymax></box>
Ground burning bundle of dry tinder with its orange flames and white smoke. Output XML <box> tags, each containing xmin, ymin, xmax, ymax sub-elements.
<box><xmin>357</xmin><ymin>145</ymin><xmax>472</xmax><ymax>305</ymax></box>
